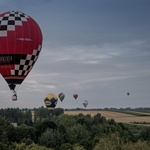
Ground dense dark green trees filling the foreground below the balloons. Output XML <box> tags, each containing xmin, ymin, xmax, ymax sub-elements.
<box><xmin>0</xmin><ymin>107</ymin><xmax>150</xmax><ymax>150</ymax></box>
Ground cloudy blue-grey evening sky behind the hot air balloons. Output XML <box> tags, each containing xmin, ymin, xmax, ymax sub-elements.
<box><xmin>0</xmin><ymin>0</ymin><xmax>150</xmax><ymax>109</ymax></box>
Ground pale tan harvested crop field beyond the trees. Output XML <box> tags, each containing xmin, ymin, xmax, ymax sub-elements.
<box><xmin>64</xmin><ymin>110</ymin><xmax>150</xmax><ymax>124</ymax></box>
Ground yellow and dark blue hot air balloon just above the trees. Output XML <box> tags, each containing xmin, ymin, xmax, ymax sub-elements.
<box><xmin>44</xmin><ymin>93</ymin><xmax>58</xmax><ymax>112</ymax></box>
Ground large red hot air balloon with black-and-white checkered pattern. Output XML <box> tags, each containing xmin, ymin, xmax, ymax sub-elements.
<box><xmin>0</xmin><ymin>11</ymin><xmax>42</xmax><ymax>100</ymax></box>
